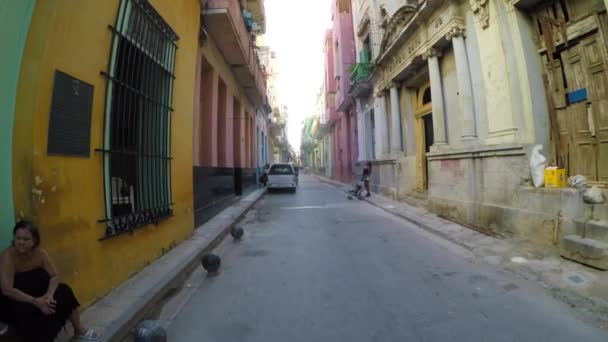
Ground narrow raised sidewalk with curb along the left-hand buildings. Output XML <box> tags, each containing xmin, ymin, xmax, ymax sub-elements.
<box><xmin>83</xmin><ymin>189</ymin><xmax>266</xmax><ymax>342</ymax></box>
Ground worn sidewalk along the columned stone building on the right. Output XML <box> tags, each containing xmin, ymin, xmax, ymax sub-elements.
<box><xmin>314</xmin><ymin>175</ymin><xmax>608</xmax><ymax>328</ymax></box>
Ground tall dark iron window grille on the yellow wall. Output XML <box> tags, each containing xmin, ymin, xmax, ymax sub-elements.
<box><xmin>98</xmin><ymin>0</ymin><xmax>179</xmax><ymax>238</ymax></box>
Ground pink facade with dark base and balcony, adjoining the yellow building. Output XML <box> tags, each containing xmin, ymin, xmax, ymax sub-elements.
<box><xmin>193</xmin><ymin>0</ymin><xmax>270</xmax><ymax>227</ymax></box>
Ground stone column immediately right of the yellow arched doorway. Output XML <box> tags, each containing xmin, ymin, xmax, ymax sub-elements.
<box><xmin>423</xmin><ymin>48</ymin><xmax>448</xmax><ymax>146</ymax></box>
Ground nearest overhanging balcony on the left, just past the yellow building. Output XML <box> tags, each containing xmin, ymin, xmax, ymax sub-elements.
<box><xmin>203</xmin><ymin>0</ymin><xmax>266</xmax><ymax>106</ymax></box>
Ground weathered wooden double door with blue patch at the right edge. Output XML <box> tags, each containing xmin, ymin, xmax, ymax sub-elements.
<box><xmin>533</xmin><ymin>1</ymin><xmax>608</xmax><ymax>186</ymax></box>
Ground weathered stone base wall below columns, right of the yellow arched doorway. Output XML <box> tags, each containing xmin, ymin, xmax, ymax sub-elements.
<box><xmin>429</xmin><ymin>152</ymin><xmax>608</xmax><ymax>247</ymax></box>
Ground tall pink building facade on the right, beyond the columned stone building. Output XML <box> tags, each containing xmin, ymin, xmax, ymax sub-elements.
<box><xmin>326</xmin><ymin>0</ymin><xmax>358</xmax><ymax>183</ymax></box>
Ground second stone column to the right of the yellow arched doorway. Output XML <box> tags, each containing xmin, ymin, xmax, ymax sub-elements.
<box><xmin>446</xmin><ymin>27</ymin><xmax>477</xmax><ymax>140</ymax></box>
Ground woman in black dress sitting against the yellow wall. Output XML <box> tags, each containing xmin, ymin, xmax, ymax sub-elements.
<box><xmin>0</xmin><ymin>221</ymin><xmax>99</xmax><ymax>342</ymax></box>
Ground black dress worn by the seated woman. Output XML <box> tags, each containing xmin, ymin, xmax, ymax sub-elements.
<box><xmin>3</xmin><ymin>267</ymin><xmax>80</xmax><ymax>342</ymax></box>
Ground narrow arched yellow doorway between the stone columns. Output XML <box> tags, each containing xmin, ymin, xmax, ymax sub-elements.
<box><xmin>414</xmin><ymin>82</ymin><xmax>435</xmax><ymax>192</ymax></box>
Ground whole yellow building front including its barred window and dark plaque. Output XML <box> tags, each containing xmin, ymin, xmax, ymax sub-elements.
<box><xmin>13</xmin><ymin>0</ymin><xmax>201</xmax><ymax>305</ymax></box>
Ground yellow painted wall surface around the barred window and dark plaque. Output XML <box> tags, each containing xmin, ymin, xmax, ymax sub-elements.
<box><xmin>13</xmin><ymin>0</ymin><xmax>200</xmax><ymax>305</ymax></box>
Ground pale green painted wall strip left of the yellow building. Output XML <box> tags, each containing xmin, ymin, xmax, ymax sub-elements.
<box><xmin>0</xmin><ymin>0</ymin><xmax>36</xmax><ymax>249</ymax></box>
